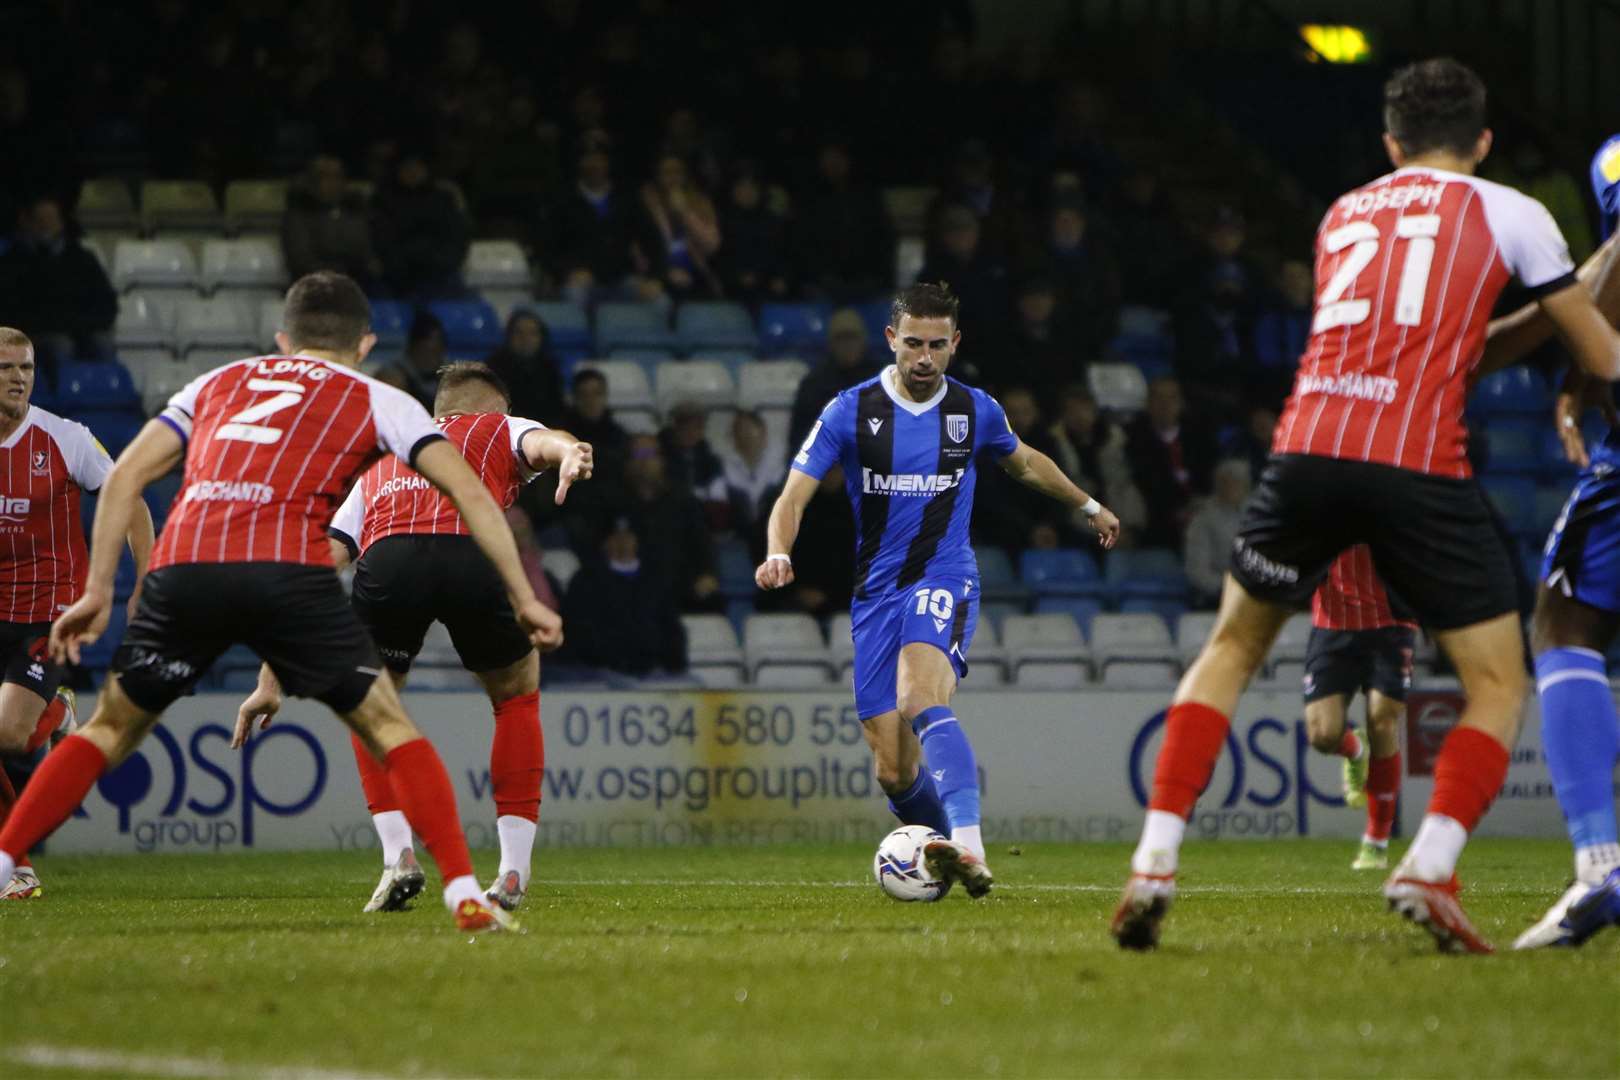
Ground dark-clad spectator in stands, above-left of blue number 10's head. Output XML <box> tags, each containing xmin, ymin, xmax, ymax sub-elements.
<box><xmin>792</xmin><ymin>139</ymin><xmax>894</xmax><ymax>303</ymax></box>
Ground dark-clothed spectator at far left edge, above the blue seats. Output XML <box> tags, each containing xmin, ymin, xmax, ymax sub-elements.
<box><xmin>0</xmin><ymin>196</ymin><xmax>118</xmax><ymax>382</ymax></box>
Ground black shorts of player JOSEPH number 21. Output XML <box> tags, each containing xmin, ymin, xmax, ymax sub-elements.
<box><xmin>1231</xmin><ymin>453</ymin><xmax>1520</xmax><ymax>630</ymax></box>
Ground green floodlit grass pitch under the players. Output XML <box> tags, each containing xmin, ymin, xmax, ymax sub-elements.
<box><xmin>0</xmin><ymin>840</ymin><xmax>1620</xmax><ymax>1077</ymax></box>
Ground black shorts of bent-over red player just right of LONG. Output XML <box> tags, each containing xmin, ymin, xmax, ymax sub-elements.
<box><xmin>353</xmin><ymin>536</ymin><xmax>535</xmax><ymax>674</ymax></box>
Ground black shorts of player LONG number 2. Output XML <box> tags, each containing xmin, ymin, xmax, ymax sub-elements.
<box><xmin>112</xmin><ymin>562</ymin><xmax>382</xmax><ymax>712</ymax></box>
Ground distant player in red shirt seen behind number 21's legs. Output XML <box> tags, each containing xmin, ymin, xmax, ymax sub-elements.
<box><xmin>1304</xmin><ymin>544</ymin><xmax>1418</xmax><ymax>870</ymax></box>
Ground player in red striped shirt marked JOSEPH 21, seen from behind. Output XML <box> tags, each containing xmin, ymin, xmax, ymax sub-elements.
<box><xmin>1111</xmin><ymin>60</ymin><xmax>1620</xmax><ymax>952</ymax></box>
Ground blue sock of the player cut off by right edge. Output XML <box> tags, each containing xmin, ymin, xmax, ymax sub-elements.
<box><xmin>1536</xmin><ymin>648</ymin><xmax>1620</xmax><ymax>850</ymax></box>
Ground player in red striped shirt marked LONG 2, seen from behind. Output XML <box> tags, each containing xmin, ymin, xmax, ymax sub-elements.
<box><xmin>0</xmin><ymin>272</ymin><xmax>562</xmax><ymax>931</ymax></box>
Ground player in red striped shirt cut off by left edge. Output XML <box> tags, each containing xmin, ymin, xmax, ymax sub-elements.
<box><xmin>0</xmin><ymin>327</ymin><xmax>152</xmax><ymax>900</ymax></box>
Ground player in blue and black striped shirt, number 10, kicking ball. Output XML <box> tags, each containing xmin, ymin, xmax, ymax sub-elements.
<box><xmin>755</xmin><ymin>283</ymin><xmax>1119</xmax><ymax>897</ymax></box>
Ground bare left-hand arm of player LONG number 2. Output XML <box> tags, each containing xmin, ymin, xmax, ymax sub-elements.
<box><xmin>50</xmin><ymin>419</ymin><xmax>186</xmax><ymax>664</ymax></box>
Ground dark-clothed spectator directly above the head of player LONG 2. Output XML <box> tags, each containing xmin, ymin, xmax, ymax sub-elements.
<box><xmin>282</xmin><ymin>154</ymin><xmax>382</xmax><ymax>291</ymax></box>
